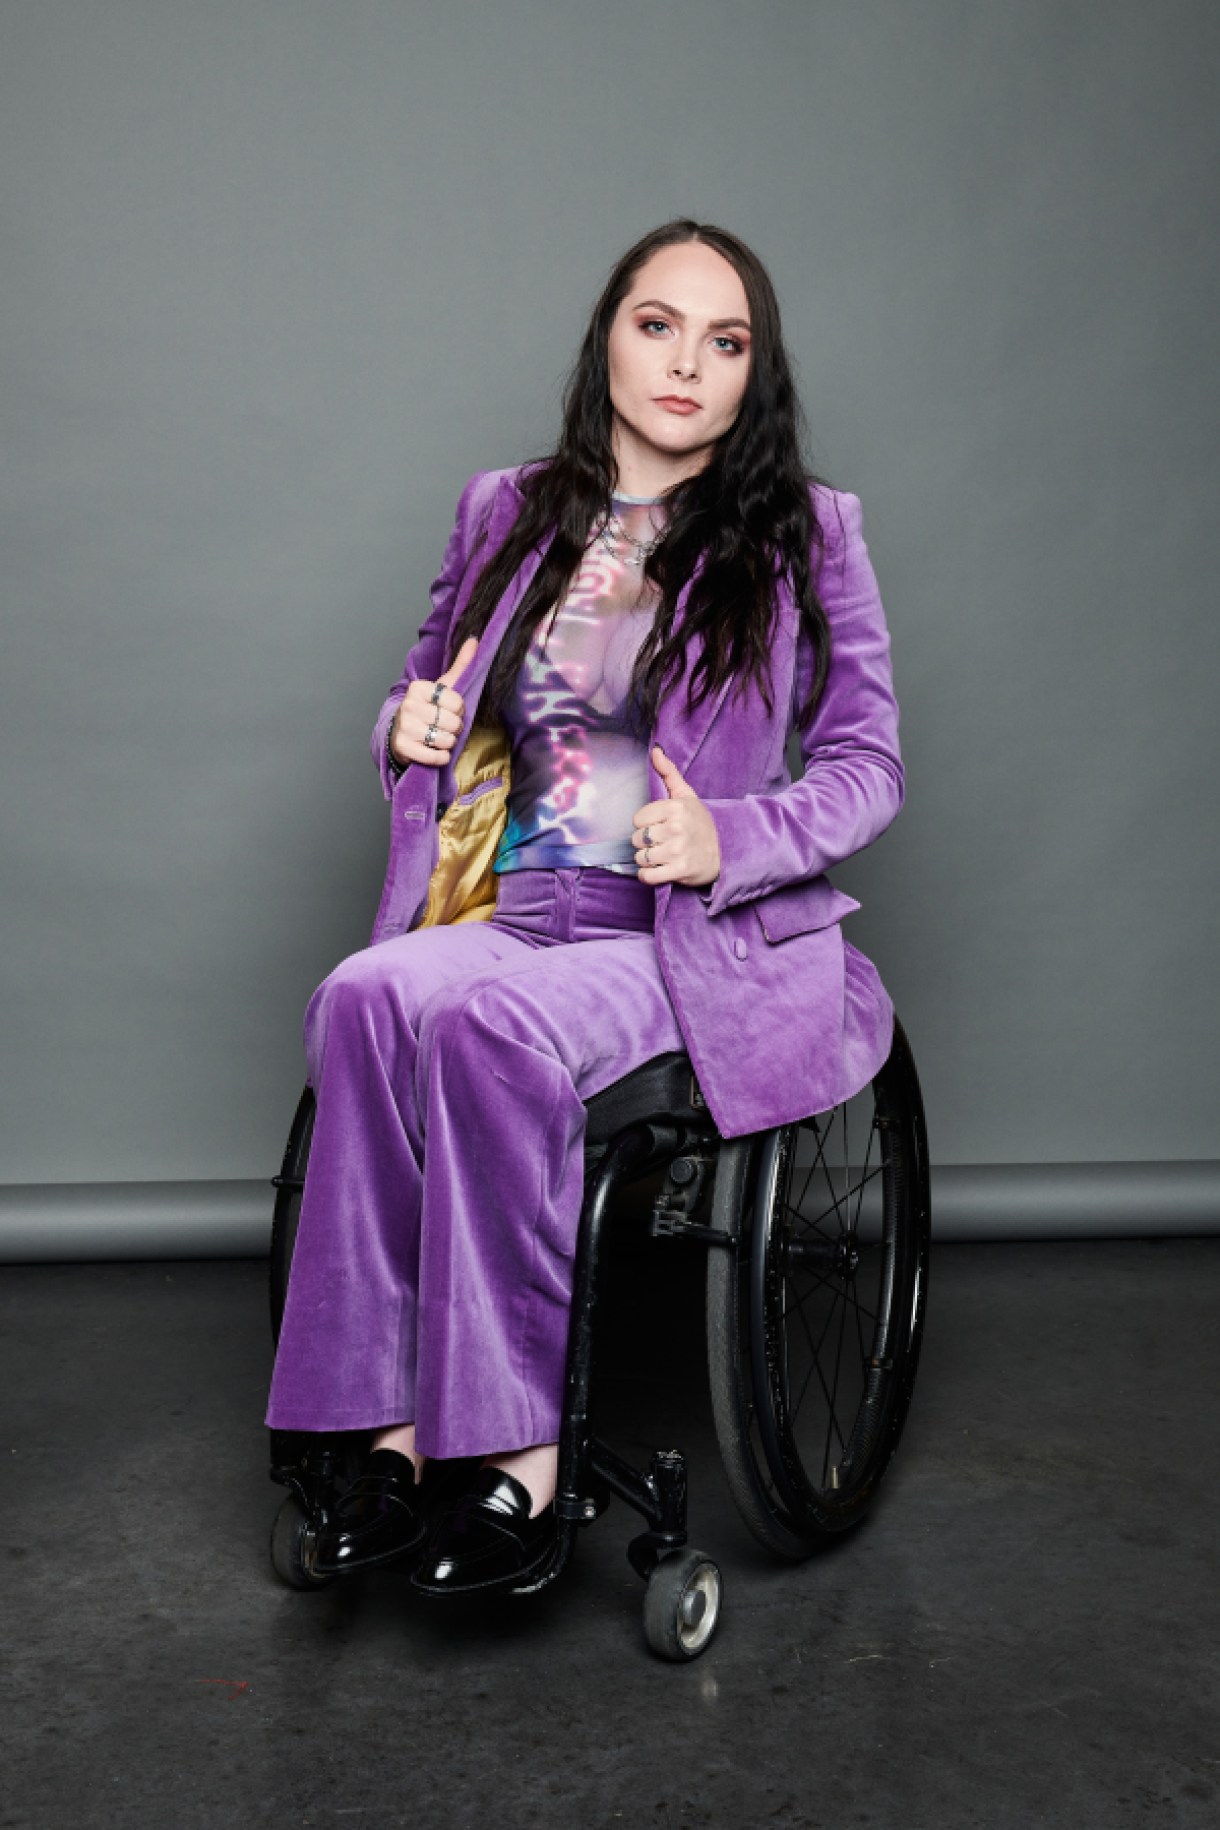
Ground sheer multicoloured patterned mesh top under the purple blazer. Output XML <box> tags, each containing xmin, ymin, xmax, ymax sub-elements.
<box><xmin>494</xmin><ymin>494</ymin><xmax>664</xmax><ymax>877</ymax></box>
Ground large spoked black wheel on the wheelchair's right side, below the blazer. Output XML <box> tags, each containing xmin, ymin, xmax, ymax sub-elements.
<box><xmin>708</xmin><ymin>1019</ymin><xmax>931</xmax><ymax>1559</ymax></box>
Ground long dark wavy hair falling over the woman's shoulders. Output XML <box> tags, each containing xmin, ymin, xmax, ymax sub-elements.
<box><xmin>450</xmin><ymin>218</ymin><xmax>830</xmax><ymax>730</ymax></box>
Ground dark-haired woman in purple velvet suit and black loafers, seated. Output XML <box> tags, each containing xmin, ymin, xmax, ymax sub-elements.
<box><xmin>267</xmin><ymin>221</ymin><xmax>915</xmax><ymax>1625</ymax></box>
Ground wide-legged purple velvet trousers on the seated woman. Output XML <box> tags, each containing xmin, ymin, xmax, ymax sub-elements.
<box><xmin>267</xmin><ymin>867</ymin><xmax>684</xmax><ymax>1457</ymax></box>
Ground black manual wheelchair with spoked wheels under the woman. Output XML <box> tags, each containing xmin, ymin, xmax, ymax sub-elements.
<box><xmin>271</xmin><ymin>1017</ymin><xmax>931</xmax><ymax>1662</ymax></box>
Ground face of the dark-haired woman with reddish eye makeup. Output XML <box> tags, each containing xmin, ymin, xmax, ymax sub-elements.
<box><xmin>607</xmin><ymin>242</ymin><xmax>750</xmax><ymax>487</ymax></box>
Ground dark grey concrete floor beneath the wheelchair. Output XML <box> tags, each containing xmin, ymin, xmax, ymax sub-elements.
<box><xmin>0</xmin><ymin>1241</ymin><xmax>1220</xmax><ymax>1830</ymax></box>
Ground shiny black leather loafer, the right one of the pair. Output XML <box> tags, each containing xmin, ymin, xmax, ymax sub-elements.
<box><xmin>412</xmin><ymin>1468</ymin><xmax>556</xmax><ymax>1596</ymax></box>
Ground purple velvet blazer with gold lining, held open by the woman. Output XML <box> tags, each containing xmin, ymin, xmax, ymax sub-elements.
<box><xmin>371</xmin><ymin>470</ymin><xmax>904</xmax><ymax>1136</ymax></box>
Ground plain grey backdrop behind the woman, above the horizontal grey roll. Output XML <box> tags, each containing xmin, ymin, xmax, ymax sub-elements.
<box><xmin>0</xmin><ymin>0</ymin><xmax>1220</xmax><ymax>1244</ymax></box>
